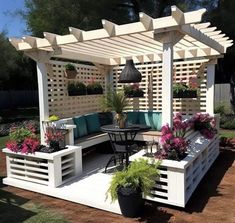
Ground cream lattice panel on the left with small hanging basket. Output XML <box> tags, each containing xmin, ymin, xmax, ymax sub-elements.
<box><xmin>47</xmin><ymin>61</ymin><xmax>105</xmax><ymax>118</ymax></box>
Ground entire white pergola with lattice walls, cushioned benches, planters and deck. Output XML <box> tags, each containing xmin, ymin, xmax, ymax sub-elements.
<box><xmin>3</xmin><ymin>6</ymin><xmax>232</xmax><ymax>216</ymax></box>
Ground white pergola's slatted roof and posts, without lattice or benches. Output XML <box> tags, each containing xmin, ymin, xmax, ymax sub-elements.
<box><xmin>10</xmin><ymin>6</ymin><xmax>233</xmax><ymax>136</ymax></box>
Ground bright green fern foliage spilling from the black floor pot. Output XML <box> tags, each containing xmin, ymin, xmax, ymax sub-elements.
<box><xmin>107</xmin><ymin>159</ymin><xmax>160</xmax><ymax>201</ymax></box>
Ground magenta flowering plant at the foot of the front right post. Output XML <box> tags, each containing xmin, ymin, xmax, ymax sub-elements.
<box><xmin>155</xmin><ymin>113</ymin><xmax>190</xmax><ymax>160</ymax></box>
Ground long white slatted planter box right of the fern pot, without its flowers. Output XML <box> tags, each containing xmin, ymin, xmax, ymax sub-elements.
<box><xmin>130</xmin><ymin>134</ymin><xmax>219</xmax><ymax>207</ymax></box>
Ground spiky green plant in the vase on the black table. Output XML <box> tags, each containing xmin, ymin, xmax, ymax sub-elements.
<box><xmin>101</xmin><ymin>89</ymin><xmax>129</xmax><ymax>114</ymax></box>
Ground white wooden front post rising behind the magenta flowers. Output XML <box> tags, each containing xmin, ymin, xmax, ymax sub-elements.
<box><xmin>162</xmin><ymin>42</ymin><xmax>173</xmax><ymax>127</ymax></box>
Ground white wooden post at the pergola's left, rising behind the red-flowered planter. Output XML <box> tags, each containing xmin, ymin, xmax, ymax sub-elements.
<box><xmin>37</xmin><ymin>62</ymin><xmax>49</xmax><ymax>144</ymax></box>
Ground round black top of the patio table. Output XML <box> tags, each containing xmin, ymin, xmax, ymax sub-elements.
<box><xmin>101</xmin><ymin>124</ymin><xmax>150</xmax><ymax>132</ymax></box>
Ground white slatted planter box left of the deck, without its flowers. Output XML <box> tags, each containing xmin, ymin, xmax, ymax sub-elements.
<box><xmin>3</xmin><ymin>146</ymin><xmax>82</xmax><ymax>187</ymax></box>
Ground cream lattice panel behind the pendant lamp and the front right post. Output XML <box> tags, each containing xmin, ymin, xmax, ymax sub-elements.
<box><xmin>113</xmin><ymin>60</ymin><xmax>207</xmax><ymax>115</ymax></box>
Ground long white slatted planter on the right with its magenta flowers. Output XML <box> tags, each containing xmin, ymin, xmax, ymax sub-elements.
<box><xmin>130</xmin><ymin>114</ymin><xmax>219</xmax><ymax>207</ymax></box>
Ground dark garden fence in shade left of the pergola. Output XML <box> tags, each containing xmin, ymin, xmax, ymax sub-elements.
<box><xmin>0</xmin><ymin>90</ymin><xmax>38</xmax><ymax>109</ymax></box>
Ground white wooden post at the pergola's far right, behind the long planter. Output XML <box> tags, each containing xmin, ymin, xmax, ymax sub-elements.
<box><xmin>206</xmin><ymin>61</ymin><xmax>216</xmax><ymax>115</ymax></box>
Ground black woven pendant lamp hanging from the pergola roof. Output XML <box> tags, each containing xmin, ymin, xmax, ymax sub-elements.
<box><xmin>118</xmin><ymin>60</ymin><xmax>142</xmax><ymax>83</ymax></box>
